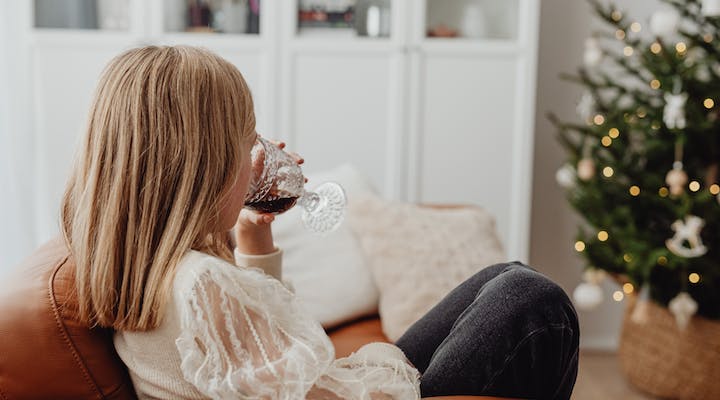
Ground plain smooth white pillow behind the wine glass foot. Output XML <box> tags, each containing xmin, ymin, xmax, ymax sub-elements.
<box><xmin>273</xmin><ymin>164</ymin><xmax>379</xmax><ymax>328</ymax></box>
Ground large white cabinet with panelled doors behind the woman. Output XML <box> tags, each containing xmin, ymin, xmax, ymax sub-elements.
<box><xmin>11</xmin><ymin>0</ymin><xmax>538</xmax><ymax>260</ymax></box>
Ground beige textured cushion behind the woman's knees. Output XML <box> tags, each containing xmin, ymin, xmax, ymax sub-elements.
<box><xmin>348</xmin><ymin>196</ymin><xmax>505</xmax><ymax>342</ymax></box>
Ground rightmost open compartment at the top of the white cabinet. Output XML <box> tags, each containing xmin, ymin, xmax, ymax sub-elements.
<box><xmin>424</xmin><ymin>0</ymin><xmax>519</xmax><ymax>40</ymax></box>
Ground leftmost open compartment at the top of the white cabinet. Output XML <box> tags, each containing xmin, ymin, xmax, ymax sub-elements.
<box><xmin>33</xmin><ymin>0</ymin><xmax>130</xmax><ymax>31</ymax></box>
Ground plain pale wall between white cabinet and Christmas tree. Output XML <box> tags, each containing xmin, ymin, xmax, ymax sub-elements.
<box><xmin>530</xmin><ymin>0</ymin><xmax>658</xmax><ymax>349</ymax></box>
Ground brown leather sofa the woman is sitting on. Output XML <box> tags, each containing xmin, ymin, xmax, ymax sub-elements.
<box><xmin>0</xmin><ymin>239</ymin><xmax>510</xmax><ymax>400</ymax></box>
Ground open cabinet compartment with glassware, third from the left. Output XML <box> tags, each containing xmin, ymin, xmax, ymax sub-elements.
<box><xmin>297</xmin><ymin>0</ymin><xmax>392</xmax><ymax>39</ymax></box>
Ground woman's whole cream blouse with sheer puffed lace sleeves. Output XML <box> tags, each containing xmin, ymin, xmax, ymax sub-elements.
<box><xmin>114</xmin><ymin>250</ymin><xmax>420</xmax><ymax>400</ymax></box>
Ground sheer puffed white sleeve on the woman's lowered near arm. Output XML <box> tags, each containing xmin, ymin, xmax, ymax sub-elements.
<box><xmin>175</xmin><ymin>255</ymin><xmax>419</xmax><ymax>400</ymax></box>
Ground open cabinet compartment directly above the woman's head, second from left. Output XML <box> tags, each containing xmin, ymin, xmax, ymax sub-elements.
<box><xmin>163</xmin><ymin>0</ymin><xmax>261</xmax><ymax>35</ymax></box>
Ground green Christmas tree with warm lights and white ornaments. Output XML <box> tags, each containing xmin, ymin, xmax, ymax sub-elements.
<box><xmin>550</xmin><ymin>0</ymin><xmax>720</xmax><ymax>327</ymax></box>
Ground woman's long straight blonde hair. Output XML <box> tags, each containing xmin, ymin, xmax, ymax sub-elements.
<box><xmin>61</xmin><ymin>46</ymin><xmax>255</xmax><ymax>331</ymax></box>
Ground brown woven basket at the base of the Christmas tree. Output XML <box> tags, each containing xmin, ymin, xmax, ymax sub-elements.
<box><xmin>618</xmin><ymin>296</ymin><xmax>720</xmax><ymax>399</ymax></box>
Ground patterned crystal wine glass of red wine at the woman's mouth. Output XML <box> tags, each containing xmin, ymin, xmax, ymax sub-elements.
<box><xmin>245</xmin><ymin>137</ymin><xmax>347</xmax><ymax>234</ymax></box>
